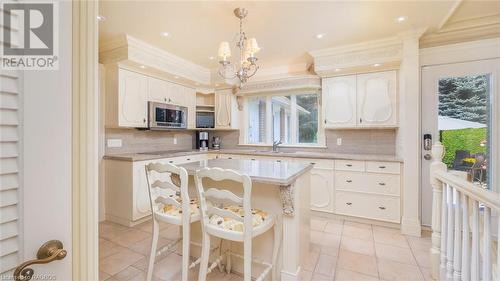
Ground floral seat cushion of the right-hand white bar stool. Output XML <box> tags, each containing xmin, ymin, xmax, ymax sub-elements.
<box><xmin>209</xmin><ymin>203</ymin><xmax>269</xmax><ymax>232</ymax></box>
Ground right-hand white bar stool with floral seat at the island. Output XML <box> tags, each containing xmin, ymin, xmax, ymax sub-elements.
<box><xmin>195</xmin><ymin>168</ymin><xmax>281</xmax><ymax>281</ymax></box>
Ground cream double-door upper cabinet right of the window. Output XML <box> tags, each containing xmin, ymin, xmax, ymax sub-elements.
<box><xmin>322</xmin><ymin>70</ymin><xmax>398</xmax><ymax>129</ymax></box>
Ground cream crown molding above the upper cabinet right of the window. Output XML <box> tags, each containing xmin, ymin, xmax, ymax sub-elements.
<box><xmin>309</xmin><ymin>36</ymin><xmax>403</xmax><ymax>77</ymax></box>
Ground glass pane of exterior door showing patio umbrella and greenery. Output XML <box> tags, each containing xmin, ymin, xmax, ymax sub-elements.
<box><xmin>438</xmin><ymin>75</ymin><xmax>491</xmax><ymax>188</ymax></box>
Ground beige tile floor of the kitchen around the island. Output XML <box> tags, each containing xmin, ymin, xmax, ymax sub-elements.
<box><xmin>99</xmin><ymin>217</ymin><xmax>432</xmax><ymax>281</ymax></box>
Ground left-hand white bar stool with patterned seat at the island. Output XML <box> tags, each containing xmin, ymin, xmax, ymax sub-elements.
<box><xmin>146</xmin><ymin>163</ymin><xmax>201</xmax><ymax>281</ymax></box>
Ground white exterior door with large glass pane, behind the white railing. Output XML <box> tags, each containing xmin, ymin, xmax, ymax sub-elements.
<box><xmin>421</xmin><ymin>59</ymin><xmax>500</xmax><ymax>225</ymax></box>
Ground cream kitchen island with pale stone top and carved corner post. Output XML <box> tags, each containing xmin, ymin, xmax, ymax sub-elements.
<box><xmin>180</xmin><ymin>159</ymin><xmax>312</xmax><ymax>281</ymax></box>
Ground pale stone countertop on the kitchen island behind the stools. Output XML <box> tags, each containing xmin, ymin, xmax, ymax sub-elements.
<box><xmin>179</xmin><ymin>159</ymin><xmax>313</xmax><ymax>186</ymax></box>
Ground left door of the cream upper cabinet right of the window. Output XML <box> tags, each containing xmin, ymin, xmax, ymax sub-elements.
<box><xmin>322</xmin><ymin>75</ymin><xmax>356</xmax><ymax>128</ymax></box>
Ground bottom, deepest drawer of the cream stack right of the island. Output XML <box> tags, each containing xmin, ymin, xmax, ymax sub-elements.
<box><xmin>335</xmin><ymin>191</ymin><xmax>401</xmax><ymax>223</ymax></box>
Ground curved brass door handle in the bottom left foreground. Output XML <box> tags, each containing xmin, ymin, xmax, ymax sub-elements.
<box><xmin>14</xmin><ymin>240</ymin><xmax>68</xmax><ymax>280</ymax></box>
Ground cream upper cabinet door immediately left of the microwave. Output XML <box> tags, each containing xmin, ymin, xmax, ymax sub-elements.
<box><xmin>118</xmin><ymin>69</ymin><xmax>148</xmax><ymax>128</ymax></box>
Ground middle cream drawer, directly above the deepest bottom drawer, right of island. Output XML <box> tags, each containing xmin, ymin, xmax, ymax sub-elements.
<box><xmin>335</xmin><ymin>171</ymin><xmax>401</xmax><ymax>195</ymax></box>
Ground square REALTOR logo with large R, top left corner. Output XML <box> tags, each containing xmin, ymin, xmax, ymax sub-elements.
<box><xmin>0</xmin><ymin>3</ymin><xmax>58</xmax><ymax>70</ymax></box>
